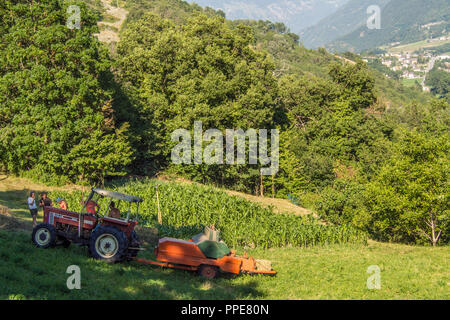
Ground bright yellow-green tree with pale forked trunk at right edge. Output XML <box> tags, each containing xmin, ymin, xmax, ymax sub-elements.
<box><xmin>357</xmin><ymin>129</ymin><xmax>450</xmax><ymax>245</ymax></box>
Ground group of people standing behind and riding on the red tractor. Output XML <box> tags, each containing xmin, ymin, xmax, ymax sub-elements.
<box><xmin>27</xmin><ymin>191</ymin><xmax>120</xmax><ymax>228</ymax></box>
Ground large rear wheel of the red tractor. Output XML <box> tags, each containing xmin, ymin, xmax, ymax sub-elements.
<box><xmin>89</xmin><ymin>226</ymin><xmax>128</xmax><ymax>263</ymax></box>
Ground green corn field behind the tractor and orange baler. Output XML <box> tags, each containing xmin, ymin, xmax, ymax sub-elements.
<box><xmin>49</xmin><ymin>179</ymin><xmax>367</xmax><ymax>248</ymax></box>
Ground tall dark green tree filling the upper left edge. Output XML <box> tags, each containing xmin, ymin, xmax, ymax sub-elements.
<box><xmin>0</xmin><ymin>0</ymin><xmax>131</xmax><ymax>181</ymax></box>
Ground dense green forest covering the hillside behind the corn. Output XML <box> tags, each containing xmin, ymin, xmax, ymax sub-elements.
<box><xmin>0</xmin><ymin>0</ymin><xmax>450</xmax><ymax>245</ymax></box>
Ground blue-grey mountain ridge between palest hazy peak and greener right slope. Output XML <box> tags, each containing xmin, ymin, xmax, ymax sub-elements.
<box><xmin>300</xmin><ymin>0</ymin><xmax>390</xmax><ymax>48</ymax></box>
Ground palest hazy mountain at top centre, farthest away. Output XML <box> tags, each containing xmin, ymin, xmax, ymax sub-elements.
<box><xmin>187</xmin><ymin>0</ymin><xmax>349</xmax><ymax>33</ymax></box>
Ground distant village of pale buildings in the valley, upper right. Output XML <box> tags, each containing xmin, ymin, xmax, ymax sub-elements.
<box><xmin>364</xmin><ymin>36</ymin><xmax>450</xmax><ymax>91</ymax></box>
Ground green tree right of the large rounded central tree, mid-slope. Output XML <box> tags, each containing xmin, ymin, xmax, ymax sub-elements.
<box><xmin>279</xmin><ymin>63</ymin><xmax>386</xmax><ymax>190</ymax></box>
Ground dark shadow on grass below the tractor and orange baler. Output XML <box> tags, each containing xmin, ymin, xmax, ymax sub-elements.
<box><xmin>0</xmin><ymin>230</ymin><xmax>264</xmax><ymax>300</ymax></box>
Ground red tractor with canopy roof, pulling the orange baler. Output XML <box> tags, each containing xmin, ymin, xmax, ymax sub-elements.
<box><xmin>32</xmin><ymin>189</ymin><xmax>142</xmax><ymax>262</ymax></box>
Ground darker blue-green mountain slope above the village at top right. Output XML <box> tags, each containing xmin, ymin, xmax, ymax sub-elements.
<box><xmin>327</xmin><ymin>0</ymin><xmax>450</xmax><ymax>52</ymax></box>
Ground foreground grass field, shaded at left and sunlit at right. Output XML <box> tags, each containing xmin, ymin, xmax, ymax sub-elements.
<box><xmin>0</xmin><ymin>175</ymin><xmax>450</xmax><ymax>299</ymax></box>
